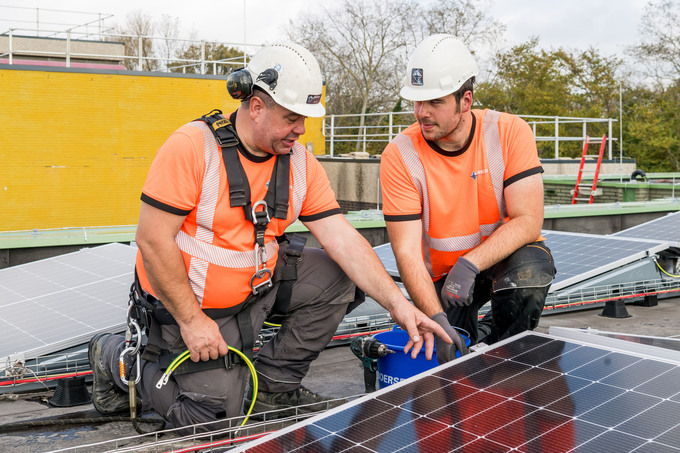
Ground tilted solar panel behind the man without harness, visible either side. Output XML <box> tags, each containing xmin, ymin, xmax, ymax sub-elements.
<box><xmin>374</xmin><ymin>230</ymin><xmax>668</xmax><ymax>292</ymax></box>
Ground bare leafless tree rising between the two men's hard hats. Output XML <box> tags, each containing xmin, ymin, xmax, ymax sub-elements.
<box><xmin>289</xmin><ymin>0</ymin><xmax>413</xmax><ymax>146</ymax></box>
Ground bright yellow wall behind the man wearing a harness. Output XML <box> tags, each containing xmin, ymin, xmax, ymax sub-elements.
<box><xmin>0</xmin><ymin>66</ymin><xmax>325</xmax><ymax>231</ymax></box>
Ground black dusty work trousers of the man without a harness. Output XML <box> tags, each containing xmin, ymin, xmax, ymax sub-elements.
<box><xmin>435</xmin><ymin>241</ymin><xmax>556</xmax><ymax>345</ymax></box>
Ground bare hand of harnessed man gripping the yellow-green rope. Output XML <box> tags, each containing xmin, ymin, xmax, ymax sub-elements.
<box><xmin>180</xmin><ymin>313</ymin><xmax>229</xmax><ymax>362</ymax></box>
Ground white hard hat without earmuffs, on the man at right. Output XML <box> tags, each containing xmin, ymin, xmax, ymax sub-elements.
<box><xmin>399</xmin><ymin>34</ymin><xmax>478</xmax><ymax>101</ymax></box>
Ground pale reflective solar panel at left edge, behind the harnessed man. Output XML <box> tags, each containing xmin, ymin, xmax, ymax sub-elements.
<box><xmin>0</xmin><ymin>243</ymin><xmax>136</xmax><ymax>365</ymax></box>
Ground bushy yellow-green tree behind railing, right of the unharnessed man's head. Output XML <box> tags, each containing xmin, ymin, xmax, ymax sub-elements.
<box><xmin>475</xmin><ymin>38</ymin><xmax>623</xmax><ymax>156</ymax></box>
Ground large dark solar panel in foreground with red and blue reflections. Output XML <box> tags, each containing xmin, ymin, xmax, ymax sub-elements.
<box><xmin>237</xmin><ymin>332</ymin><xmax>680</xmax><ymax>453</ymax></box>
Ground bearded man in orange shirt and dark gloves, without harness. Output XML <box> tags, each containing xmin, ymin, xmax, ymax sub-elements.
<box><xmin>381</xmin><ymin>34</ymin><xmax>555</xmax><ymax>363</ymax></box>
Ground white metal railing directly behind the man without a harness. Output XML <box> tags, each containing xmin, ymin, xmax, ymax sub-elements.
<box><xmin>325</xmin><ymin>111</ymin><xmax>618</xmax><ymax>159</ymax></box>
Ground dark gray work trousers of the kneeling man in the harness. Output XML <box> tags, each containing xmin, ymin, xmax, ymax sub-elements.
<box><xmin>103</xmin><ymin>244</ymin><xmax>356</xmax><ymax>430</ymax></box>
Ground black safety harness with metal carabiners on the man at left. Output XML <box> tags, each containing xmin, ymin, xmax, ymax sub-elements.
<box><xmin>121</xmin><ymin>110</ymin><xmax>307</xmax><ymax>380</ymax></box>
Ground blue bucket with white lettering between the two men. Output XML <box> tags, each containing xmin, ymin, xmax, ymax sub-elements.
<box><xmin>374</xmin><ymin>327</ymin><xmax>470</xmax><ymax>388</ymax></box>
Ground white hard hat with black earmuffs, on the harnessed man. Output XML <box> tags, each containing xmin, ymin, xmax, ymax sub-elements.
<box><xmin>247</xmin><ymin>43</ymin><xmax>326</xmax><ymax>118</ymax></box>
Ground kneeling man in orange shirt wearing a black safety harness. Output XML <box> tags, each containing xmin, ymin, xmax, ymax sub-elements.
<box><xmin>88</xmin><ymin>44</ymin><xmax>450</xmax><ymax>432</ymax></box>
